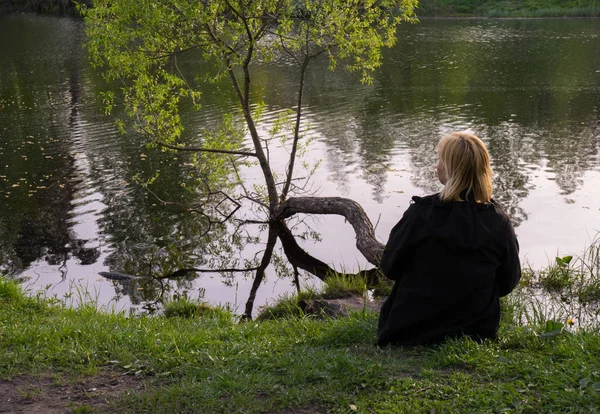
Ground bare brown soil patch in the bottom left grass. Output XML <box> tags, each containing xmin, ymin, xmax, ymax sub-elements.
<box><xmin>0</xmin><ymin>368</ymin><xmax>148</xmax><ymax>414</ymax></box>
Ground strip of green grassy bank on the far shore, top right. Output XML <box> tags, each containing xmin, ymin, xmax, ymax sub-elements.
<box><xmin>417</xmin><ymin>0</ymin><xmax>600</xmax><ymax>18</ymax></box>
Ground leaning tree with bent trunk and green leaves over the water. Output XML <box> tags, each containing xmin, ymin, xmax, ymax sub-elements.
<box><xmin>81</xmin><ymin>0</ymin><xmax>417</xmax><ymax>318</ymax></box>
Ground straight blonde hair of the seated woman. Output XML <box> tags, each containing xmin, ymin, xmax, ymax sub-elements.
<box><xmin>438</xmin><ymin>132</ymin><xmax>492</xmax><ymax>203</ymax></box>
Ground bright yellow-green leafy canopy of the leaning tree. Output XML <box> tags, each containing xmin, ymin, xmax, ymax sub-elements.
<box><xmin>80</xmin><ymin>0</ymin><xmax>417</xmax><ymax>155</ymax></box>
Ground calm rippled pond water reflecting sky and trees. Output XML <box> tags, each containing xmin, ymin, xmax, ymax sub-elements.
<box><xmin>0</xmin><ymin>16</ymin><xmax>600</xmax><ymax>309</ymax></box>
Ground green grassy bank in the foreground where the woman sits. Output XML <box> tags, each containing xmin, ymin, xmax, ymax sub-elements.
<box><xmin>0</xmin><ymin>249</ymin><xmax>600</xmax><ymax>413</ymax></box>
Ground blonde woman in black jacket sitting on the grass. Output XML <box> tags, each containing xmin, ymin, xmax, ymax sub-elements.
<box><xmin>378</xmin><ymin>132</ymin><xmax>521</xmax><ymax>345</ymax></box>
